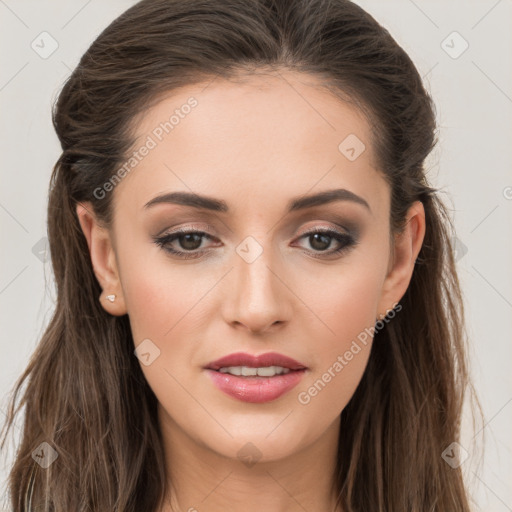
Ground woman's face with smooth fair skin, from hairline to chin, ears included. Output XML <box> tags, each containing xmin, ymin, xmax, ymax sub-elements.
<box><xmin>76</xmin><ymin>72</ymin><xmax>422</xmax><ymax>466</ymax></box>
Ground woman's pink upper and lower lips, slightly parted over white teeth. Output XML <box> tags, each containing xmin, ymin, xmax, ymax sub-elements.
<box><xmin>204</xmin><ymin>352</ymin><xmax>307</xmax><ymax>403</ymax></box>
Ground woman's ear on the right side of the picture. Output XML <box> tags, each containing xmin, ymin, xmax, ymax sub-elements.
<box><xmin>377</xmin><ymin>201</ymin><xmax>425</xmax><ymax>318</ymax></box>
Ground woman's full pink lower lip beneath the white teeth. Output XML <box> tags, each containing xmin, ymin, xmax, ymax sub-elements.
<box><xmin>206</xmin><ymin>369</ymin><xmax>306</xmax><ymax>404</ymax></box>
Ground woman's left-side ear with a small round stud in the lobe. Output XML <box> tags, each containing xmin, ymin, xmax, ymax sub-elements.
<box><xmin>76</xmin><ymin>201</ymin><xmax>127</xmax><ymax>316</ymax></box>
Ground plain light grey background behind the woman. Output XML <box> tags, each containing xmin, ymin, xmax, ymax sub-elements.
<box><xmin>0</xmin><ymin>0</ymin><xmax>512</xmax><ymax>512</ymax></box>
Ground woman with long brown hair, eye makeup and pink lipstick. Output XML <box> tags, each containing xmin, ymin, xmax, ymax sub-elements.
<box><xmin>0</xmin><ymin>0</ymin><xmax>480</xmax><ymax>512</ymax></box>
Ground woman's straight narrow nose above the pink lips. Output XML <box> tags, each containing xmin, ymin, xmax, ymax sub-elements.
<box><xmin>223</xmin><ymin>242</ymin><xmax>293</xmax><ymax>334</ymax></box>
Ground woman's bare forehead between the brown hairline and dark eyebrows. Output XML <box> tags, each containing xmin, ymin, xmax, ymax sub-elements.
<box><xmin>110</xmin><ymin>72</ymin><xmax>382</xmax><ymax>216</ymax></box>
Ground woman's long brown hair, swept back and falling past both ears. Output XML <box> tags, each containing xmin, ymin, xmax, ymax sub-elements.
<box><xmin>2</xmin><ymin>0</ymin><xmax>482</xmax><ymax>512</ymax></box>
